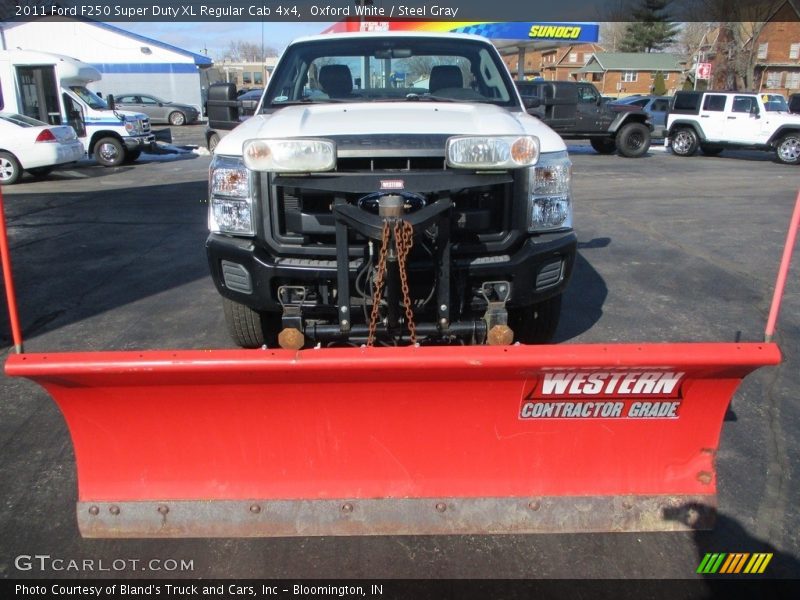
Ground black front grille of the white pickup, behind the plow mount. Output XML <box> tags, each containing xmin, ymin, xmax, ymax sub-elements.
<box><xmin>260</xmin><ymin>134</ymin><xmax>528</xmax><ymax>257</ymax></box>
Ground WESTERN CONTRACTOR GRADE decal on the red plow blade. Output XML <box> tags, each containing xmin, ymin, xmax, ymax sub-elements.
<box><xmin>519</xmin><ymin>371</ymin><xmax>685</xmax><ymax>419</ymax></box>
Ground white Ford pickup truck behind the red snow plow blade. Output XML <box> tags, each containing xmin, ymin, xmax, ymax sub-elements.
<box><xmin>206</xmin><ymin>32</ymin><xmax>576</xmax><ymax>349</ymax></box>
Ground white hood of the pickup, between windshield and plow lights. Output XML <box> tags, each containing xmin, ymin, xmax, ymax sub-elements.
<box><xmin>216</xmin><ymin>102</ymin><xmax>566</xmax><ymax>156</ymax></box>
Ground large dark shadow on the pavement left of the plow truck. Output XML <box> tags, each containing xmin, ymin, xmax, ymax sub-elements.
<box><xmin>0</xmin><ymin>178</ymin><xmax>211</xmax><ymax>345</ymax></box>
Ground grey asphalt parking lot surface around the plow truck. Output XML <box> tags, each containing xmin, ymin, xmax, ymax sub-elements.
<box><xmin>0</xmin><ymin>125</ymin><xmax>800</xmax><ymax>579</ymax></box>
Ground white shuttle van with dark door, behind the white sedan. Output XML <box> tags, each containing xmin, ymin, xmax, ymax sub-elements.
<box><xmin>0</xmin><ymin>50</ymin><xmax>155</xmax><ymax>167</ymax></box>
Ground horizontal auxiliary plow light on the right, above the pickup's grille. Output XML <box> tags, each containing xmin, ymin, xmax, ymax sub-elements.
<box><xmin>446</xmin><ymin>135</ymin><xmax>539</xmax><ymax>169</ymax></box>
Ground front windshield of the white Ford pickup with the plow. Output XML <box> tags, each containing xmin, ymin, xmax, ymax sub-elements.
<box><xmin>263</xmin><ymin>36</ymin><xmax>518</xmax><ymax>109</ymax></box>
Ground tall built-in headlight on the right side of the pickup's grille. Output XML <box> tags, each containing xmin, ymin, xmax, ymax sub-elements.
<box><xmin>528</xmin><ymin>152</ymin><xmax>572</xmax><ymax>231</ymax></box>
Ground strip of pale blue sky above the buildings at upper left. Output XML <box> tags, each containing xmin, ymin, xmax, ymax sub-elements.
<box><xmin>110</xmin><ymin>21</ymin><xmax>331</xmax><ymax>58</ymax></box>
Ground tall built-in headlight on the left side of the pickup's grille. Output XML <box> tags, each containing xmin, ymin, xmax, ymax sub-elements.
<box><xmin>208</xmin><ymin>155</ymin><xmax>255</xmax><ymax>235</ymax></box>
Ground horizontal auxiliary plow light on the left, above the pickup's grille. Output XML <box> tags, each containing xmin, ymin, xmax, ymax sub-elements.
<box><xmin>243</xmin><ymin>139</ymin><xmax>336</xmax><ymax>173</ymax></box>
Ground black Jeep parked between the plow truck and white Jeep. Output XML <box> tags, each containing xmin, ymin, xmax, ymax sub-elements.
<box><xmin>516</xmin><ymin>81</ymin><xmax>653</xmax><ymax>158</ymax></box>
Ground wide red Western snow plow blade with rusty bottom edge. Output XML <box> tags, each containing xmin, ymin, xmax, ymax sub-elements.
<box><xmin>6</xmin><ymin>343</ymin><xmax>780</xmax><ymax>537</ymax></box>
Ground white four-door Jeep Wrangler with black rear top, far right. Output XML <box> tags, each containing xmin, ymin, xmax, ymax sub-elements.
<box><xmin>667</xmin><ymin>91</ymin><xmax>800</xmax><ymax>165</ymax></box>
